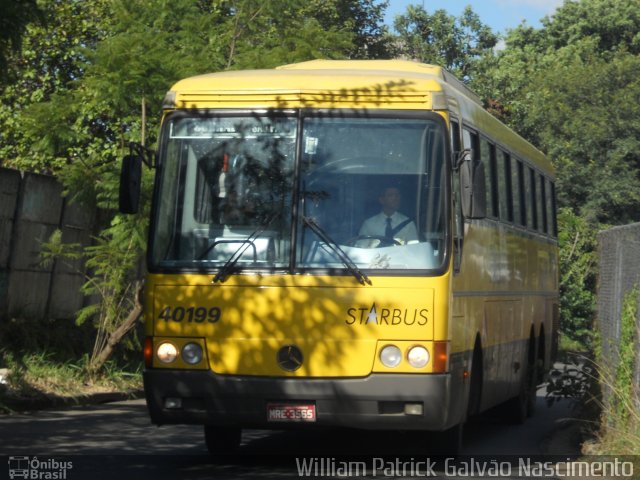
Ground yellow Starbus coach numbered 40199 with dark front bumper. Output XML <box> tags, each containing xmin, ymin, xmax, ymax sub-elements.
<box><xmin>121</xmin><ymin>60</ymin><xmax>558</xmax><ymax>453</ymax></box>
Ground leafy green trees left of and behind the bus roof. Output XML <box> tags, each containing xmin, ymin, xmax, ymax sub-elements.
<box><xmin>0</xmin><ymin>0</ymin><xmax>384</xmax><ymax>373</ymax></box>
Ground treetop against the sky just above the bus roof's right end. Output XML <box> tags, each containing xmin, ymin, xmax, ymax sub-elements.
<box><xmin>392</xmin><ymin>5</ymin><xmax>498</xmax><ymax>80</ymax></box>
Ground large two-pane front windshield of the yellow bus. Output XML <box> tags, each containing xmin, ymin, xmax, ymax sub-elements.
<box><xmin>150</xmin><ymin>110</ymin><xmax>447</xmax><ymax>273</ymax></box>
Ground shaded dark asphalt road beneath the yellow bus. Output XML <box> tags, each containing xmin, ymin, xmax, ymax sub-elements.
<box><xmin>0</xmin><ymin>391</ymin><xmax>577</xmax><ymax>480</ymax></box>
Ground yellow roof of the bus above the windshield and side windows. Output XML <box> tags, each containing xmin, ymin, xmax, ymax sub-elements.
<box><xmin>164</xmin><ymin>60</ymin><xmax>553</xmax><ymax>173</ymax></box>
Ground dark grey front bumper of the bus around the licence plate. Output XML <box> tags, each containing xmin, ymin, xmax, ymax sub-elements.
<box><xmin>144</xmin><ymin>369</ymin><xmax>465</xmax><ymax>431</ymax></box>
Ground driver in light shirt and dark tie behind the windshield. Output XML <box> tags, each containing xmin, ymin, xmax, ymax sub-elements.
<box><xmin>358</xmin><ymin>187</ymin><xmax>418</xmax><ymax>244</ymax></box>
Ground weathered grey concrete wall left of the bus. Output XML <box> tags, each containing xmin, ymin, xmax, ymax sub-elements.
<box><xmin>0</xmin><ymin>168</ymin><xmax>95</xmax><ymax>319</ymax></box>
